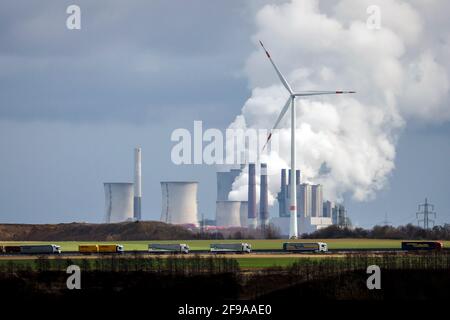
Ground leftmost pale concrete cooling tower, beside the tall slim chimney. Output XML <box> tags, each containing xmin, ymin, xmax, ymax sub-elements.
<box><xmin>104</xmin><ymin>182</ymin><xmax>134</xmax><ymax>223</ymax></box>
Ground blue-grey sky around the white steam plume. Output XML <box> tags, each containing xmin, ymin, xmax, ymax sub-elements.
<box><xmin>0</xmin><ymin>1</ymin><xmax>450</xmax><ymax>226</ymax></box>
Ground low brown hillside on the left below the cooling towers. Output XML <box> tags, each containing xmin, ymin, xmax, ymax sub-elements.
<box><xmin>0</xmin><ymin>221</ymin><xmax>193</xmax><ymax>241</ymax></box>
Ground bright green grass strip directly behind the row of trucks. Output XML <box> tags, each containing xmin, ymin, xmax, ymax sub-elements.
<box><xmin>0</xmin><ymin>239</ymin><xmax>450</xmax><ymax>251</ymax></box>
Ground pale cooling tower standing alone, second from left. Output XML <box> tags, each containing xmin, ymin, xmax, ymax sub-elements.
<box><xmin>161</xmin><ymin>181</ymin><xmax>198</xmax><ymax>226</ymax></box>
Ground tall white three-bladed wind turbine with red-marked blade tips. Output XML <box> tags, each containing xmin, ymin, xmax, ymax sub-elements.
<box><xmin>259</xmin><ymin>41</ymin><xmax>355</xmax><ymax>239</ymax></box>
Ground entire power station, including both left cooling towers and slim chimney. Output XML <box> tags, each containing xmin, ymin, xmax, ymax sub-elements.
<box><xmin>104</xmin><ymin>148</ymin><xmax>347</xmax><ymax>237</ymax></box>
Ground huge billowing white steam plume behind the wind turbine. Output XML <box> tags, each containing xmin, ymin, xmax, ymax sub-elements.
<box><xmin>230</xmin><ymin>0</ymin><xmax>450</xmax><ymax>203</ymax></box>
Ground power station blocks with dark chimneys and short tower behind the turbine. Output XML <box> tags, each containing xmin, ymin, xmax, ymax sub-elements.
<box><xmin>216</xmin><ymin>163</ymin><xmax>347</xmax><ymax>236</ymax></box>
